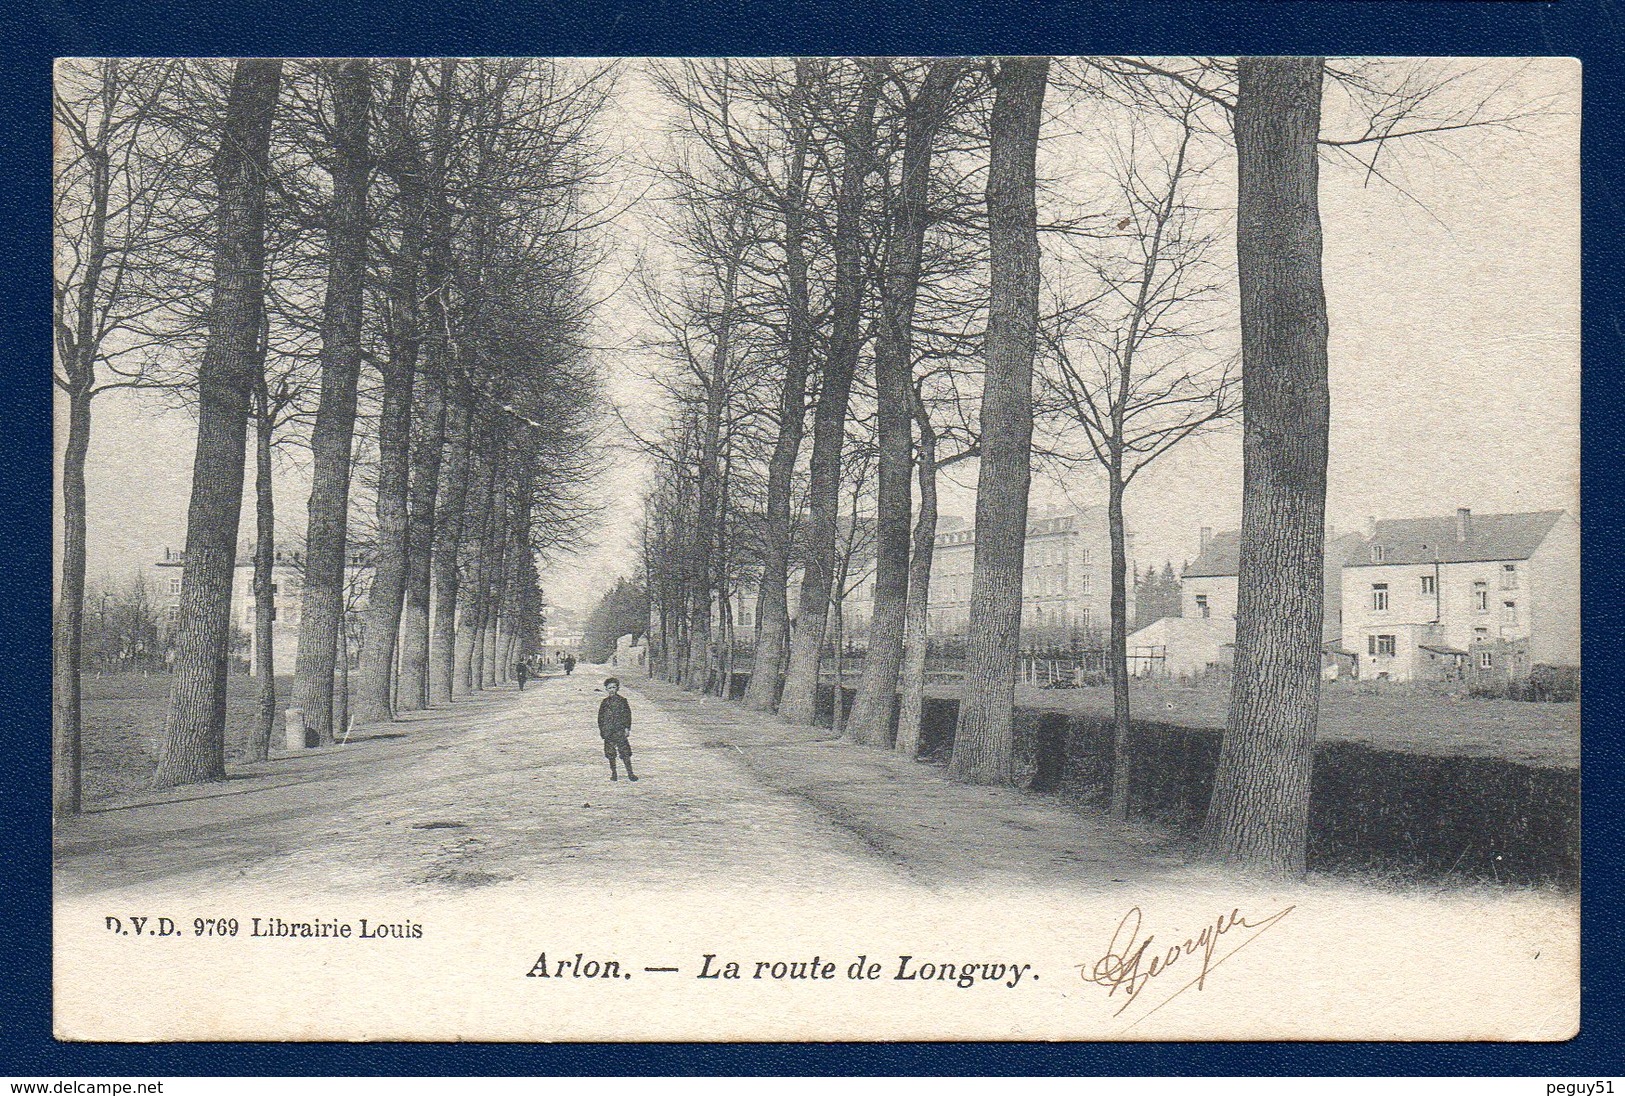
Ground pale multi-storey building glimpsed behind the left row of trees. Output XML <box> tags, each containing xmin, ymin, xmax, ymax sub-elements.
<box><xmin>153</xmin><ymin>545</ymin><xmax>372</xmax><ymax>673</ymax></box>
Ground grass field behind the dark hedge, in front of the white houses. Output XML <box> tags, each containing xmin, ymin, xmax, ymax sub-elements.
<box><xmin>926</xmin><ymin>681</ymin><xmax>1580</xmax><ymax>769</ymax></box>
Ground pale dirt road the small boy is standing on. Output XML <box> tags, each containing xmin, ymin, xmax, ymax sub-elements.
<box><xmin>57</xmin><ymin>667</ymin><xmax>1181</xmax><ymax>896</ymax></box>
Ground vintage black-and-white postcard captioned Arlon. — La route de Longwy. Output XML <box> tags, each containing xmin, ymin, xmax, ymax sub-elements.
<box><xmin>54</xmin><ymin>57</ymin><xmax>1581</xmax><ymax>1042</ymax></box>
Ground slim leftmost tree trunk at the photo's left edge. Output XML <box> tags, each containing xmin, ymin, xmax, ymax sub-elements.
<box><xmin>52</xmin><ymin>388</ymin><xmax>91</xmax><ymax>815</ymax></box>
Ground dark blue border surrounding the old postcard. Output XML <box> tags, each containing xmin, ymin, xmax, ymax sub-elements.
<box><xmin>0</xmin><ymin>0</ymin><xmax>1625</xmax><ymax>1078</ymax></box>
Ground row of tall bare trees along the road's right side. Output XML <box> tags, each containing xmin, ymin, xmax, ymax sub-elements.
<box><xmin>627</xmin><ymin>57</ymin><xmax>1506</xmax><ymax>873</ymax></box>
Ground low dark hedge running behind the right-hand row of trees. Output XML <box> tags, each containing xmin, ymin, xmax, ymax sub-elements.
<box><xmin>733</xmin><ymin>675</ymin><xmax>1580</xmax><ymax>888</ymax></box>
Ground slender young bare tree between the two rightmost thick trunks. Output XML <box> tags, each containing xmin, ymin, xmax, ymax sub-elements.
<box><xmin>1043</xmin><ymin>96</ymin><xmax>1235</xmax><ymax>818</ymax></box>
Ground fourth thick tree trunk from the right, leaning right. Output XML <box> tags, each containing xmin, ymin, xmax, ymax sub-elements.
<box><xmin>778</xmin><ymin>65</ymin><xmax>882</xmax><ymax>724</ymax></box>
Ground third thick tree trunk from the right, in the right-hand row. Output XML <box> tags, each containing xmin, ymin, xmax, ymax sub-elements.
<box><xmin>847</xmin><ymin>59</ymin><xmax>965</xmax><ymax>746</ymax></box>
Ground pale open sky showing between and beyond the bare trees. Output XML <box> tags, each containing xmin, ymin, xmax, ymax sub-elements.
<box><xmin>57</xmin><ymin>60</ymin><xmax>1580</xmax><ymax>611</ymax></box>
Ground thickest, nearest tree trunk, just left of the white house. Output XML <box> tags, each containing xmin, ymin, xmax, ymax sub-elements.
<box><xmin>1201</xmin><ymin>57</ymin><xmax>1331</xmax><ymax>876</ymax></box>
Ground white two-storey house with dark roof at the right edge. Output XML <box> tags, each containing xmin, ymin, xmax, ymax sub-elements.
<box><xmin>1342</xmin><ymin>507</ymin><xmax>1580</xmax><ymax>681</ymax></box>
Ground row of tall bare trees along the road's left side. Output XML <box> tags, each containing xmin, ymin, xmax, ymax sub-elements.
<box><xmin>54</xmin><ymin>59</ymin><xmax>613</xmax><ymax>813</ymax></box>
